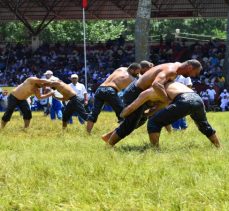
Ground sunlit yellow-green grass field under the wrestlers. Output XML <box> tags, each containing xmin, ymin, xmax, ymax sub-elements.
<box><xmin>0</xmin><ymin>112</ymin><xmax>229</xmax><ymax>210</ymax></box>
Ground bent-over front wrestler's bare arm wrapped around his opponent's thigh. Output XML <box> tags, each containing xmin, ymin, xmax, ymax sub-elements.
<box><xmin>120</xmin><ymin>88</ymin><xmax>153</xmax><ymax>118</ymax></box>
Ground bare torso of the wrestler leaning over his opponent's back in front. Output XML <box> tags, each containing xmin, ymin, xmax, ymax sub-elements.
<box><xmin>136</xmin><ymin>62</ymin><xmax>181</xmax><ymax>90</ymax></box>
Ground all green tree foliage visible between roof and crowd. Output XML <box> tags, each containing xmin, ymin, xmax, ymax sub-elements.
<box><xmin>0</xmin><ymin>18</ymin><xmax>227</xmax><ymax>43</ymax></box>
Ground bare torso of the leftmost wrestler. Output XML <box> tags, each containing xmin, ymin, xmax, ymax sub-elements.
<box><xmin>11</xmin><ymin>78</ymin><xmax>39</xmax><ymax>100</ymax></box>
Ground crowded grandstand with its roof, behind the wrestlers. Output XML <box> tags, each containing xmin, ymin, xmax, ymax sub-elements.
<box><xmin>0</xmin><ymin>0</ymin><xmax>227</xmax><ymax>111</ymax></box>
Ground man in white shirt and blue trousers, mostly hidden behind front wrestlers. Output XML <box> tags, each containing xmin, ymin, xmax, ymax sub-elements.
<box><xmin>172</xmin><ymin>75</ymin><xmax>192</xmax><ymax>130</ymax></box>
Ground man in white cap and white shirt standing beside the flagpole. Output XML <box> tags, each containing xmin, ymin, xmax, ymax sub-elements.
<box><xmin>69</xmin><ymin>74</ymin><xmax>88</xmax><ymax>124</ymax></box>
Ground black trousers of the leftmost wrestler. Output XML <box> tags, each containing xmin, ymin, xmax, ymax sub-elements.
<box><xmin>2</xmin><ymin>94</ymin><xmax>32</xmax><ymax>122</ymax></box>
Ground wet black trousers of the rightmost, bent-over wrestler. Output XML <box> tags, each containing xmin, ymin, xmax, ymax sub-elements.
<box><xmin>147</xmin><ymin>92</ymin><xmax>215</xmax><ymax>137</ymax></box>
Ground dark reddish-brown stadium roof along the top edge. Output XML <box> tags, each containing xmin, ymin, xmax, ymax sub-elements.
<box><xmin>0</xmin><ymin>0</ymin><xmax>228</xmax><ymax>22</ymax></box>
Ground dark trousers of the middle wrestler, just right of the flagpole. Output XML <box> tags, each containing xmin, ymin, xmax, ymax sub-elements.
<box><xmin>89</xmin><ymin>86</ymin><xmax>123</xmax><ymax>122</ymax></box>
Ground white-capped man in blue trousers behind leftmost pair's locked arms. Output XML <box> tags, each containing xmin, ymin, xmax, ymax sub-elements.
<box><xmin>44</xmin><ymin>70</ymin><xmax>63</xmax><ymax>120</ymax></box>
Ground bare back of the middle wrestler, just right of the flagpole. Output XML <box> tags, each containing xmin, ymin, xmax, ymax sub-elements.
<box><xmin>100</xmin><ymin>67</ymin><xmax>135</xmax><ymax>91</ymax></box>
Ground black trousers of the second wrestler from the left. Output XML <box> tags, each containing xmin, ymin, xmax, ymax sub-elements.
<box><xmin>62</xmin><ymin>95</ymin><xmax>88</xmax><ymax>122</ymax></box>
